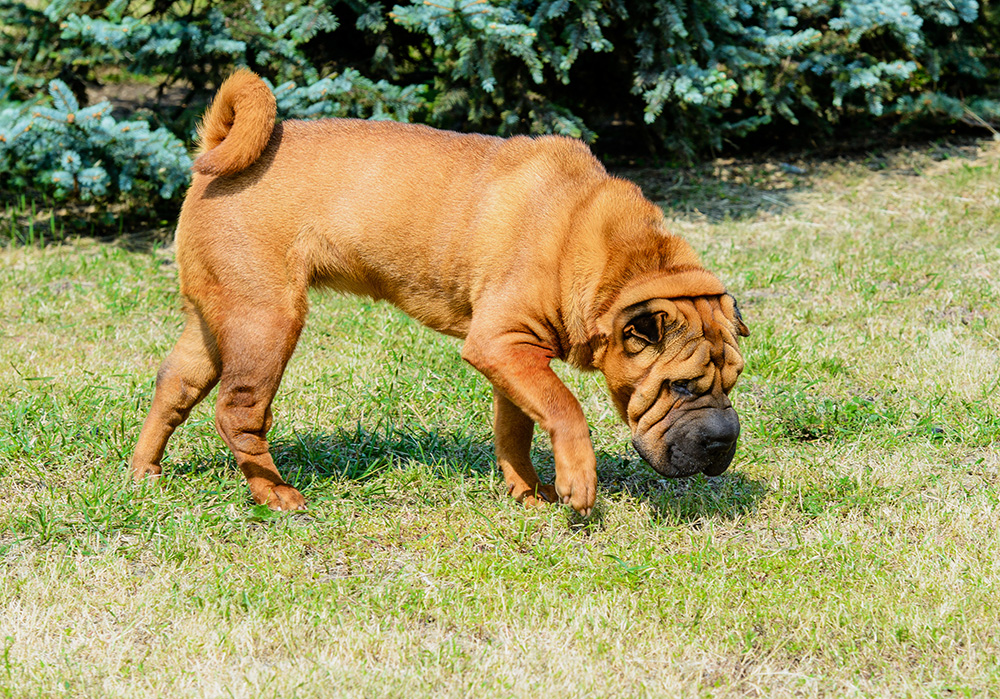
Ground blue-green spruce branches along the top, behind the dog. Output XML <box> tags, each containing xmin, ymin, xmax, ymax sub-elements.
<box><xmin>0</xmin><ymin>0</ymin><xmax>1000</xmax><ymax>208</ymax></box>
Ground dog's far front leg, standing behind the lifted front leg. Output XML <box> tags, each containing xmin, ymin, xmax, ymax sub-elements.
<box><xmin>493</xmin><ymin>387</ymin><xmax>559</xmax><ymax>505</ymax></box>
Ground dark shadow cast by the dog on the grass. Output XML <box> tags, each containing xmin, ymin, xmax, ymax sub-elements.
<box><xmin>171</xmin><ymin>424</ymin><xmax>768</xmax><ymax>527</ymax></box>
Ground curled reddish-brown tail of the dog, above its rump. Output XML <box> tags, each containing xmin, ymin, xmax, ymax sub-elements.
<box><xmin>191</xmin><ymin>69</ymin><xmax>277</xmax><ymax>175</ymax></box>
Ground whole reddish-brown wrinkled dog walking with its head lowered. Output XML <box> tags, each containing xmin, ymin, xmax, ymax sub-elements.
<box><xmin>132</xmin><ymin>71</ymin><xmax>747</xmax><ymax>514</ymax></box>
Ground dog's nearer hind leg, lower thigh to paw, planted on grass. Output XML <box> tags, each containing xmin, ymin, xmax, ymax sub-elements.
<box><xmin>215</xmin><ymin>304</ymin><xmax>305</xmax><ymax>510</ymax></box>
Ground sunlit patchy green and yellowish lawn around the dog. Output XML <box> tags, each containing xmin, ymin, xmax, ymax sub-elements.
<box><xmin>0</xmin><ymin>139</ymin><xmax>1000</xmax><ymax>697</ymax></box>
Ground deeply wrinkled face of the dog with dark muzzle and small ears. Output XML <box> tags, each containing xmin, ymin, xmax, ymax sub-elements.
<box><xmin>601</xmin><ymin>294</ymin><xmax>749</xmax><ymax>477</ymax></box>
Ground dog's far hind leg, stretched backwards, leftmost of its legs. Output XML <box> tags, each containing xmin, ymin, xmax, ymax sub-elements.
<box><xmin>132</xmin><ymin>308</ymin><xmax>220</xmax><ymax>481</ymax></box>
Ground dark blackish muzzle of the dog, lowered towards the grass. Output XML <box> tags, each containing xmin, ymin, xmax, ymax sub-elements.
<box><xmin>632</xmin><ymin>407</ymin><xmax>740</xmax><ymax>478</ymax></box>
